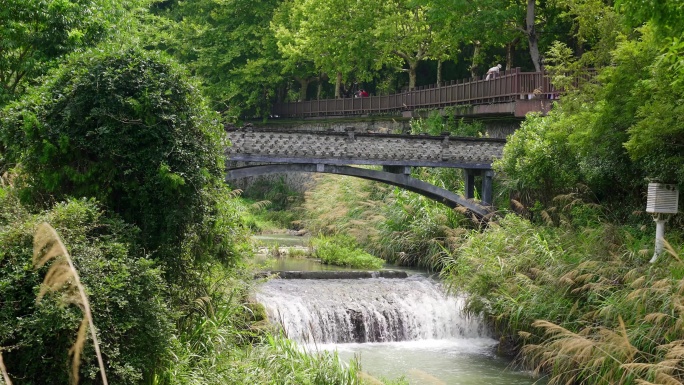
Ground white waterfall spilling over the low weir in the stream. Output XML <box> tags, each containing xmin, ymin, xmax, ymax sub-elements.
<box><xmin>256</xmin><ymin>276</ymin><xmax>487</xmax><ymax>343</ymax></box>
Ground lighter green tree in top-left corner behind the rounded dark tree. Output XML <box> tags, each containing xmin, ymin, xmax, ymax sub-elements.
<box><xmin>0</xmin><ymin>0</ymin><xmax>149</xmax><ymax>105</ymax></box>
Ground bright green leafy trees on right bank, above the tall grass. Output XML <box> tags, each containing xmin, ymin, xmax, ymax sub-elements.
<box><xmin>497</xmin><ymin>1</ymin><xmax>684</xmax><ymax>213</ymax></box>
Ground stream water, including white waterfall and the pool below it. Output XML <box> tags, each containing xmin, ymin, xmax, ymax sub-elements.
<box><xmin>251</xmin><ymin>237</ymin><xmax>544</xmax><ymax>385</ymax></box>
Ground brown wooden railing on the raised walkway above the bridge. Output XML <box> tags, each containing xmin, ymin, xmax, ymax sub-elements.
<box><xmin>272</xmin><ymin>68</ymin><xmax>558</xmax><ymax>118</ymax></box>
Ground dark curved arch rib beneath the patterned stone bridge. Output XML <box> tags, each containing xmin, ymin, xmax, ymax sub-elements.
<box><xmin>226</xmin><ymin>163</ymin><xmax>491</xmax><ymax>216</ymax></box>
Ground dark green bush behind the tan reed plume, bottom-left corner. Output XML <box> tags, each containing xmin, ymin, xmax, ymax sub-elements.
<box><xmin>0</xmin><ymin>190</ymin><xmax>173</xmax><ymax>384</ymax></box>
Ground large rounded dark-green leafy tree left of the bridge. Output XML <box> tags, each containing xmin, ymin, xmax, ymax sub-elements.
<box><xmin>0</xmin><ymin>46</ymin><xmax>246</xmax><ymax>287</ymax></box>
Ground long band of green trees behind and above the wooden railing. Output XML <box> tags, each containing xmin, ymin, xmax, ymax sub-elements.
<box><xmin>148</xmin><ymin>0</ymin><xmax>621</xmax><ymax>120</ymax></box>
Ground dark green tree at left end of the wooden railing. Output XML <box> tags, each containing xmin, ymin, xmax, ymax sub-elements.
<box><xmin>166</xmin><ymin>0</ymin><xmax>283</xmax><ymax>120</ymax></box>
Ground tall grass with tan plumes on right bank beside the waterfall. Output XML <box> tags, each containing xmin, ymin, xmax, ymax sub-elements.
<box><xmin>443</xmin><ymin>208</ymin><xmax>684</xmax><ymax>384</ymax></box>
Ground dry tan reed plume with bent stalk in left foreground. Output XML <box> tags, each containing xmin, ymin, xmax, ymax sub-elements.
<box><xmin>33</xmin><ymin>222</ymin><xmax>107</xmax><ymax>385</ymax></box>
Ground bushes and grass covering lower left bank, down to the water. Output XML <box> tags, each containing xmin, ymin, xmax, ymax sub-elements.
<box><xmin>0</xmin><ymin>181</ymin><xmax>382</xmax><ymax>385</ymax></box>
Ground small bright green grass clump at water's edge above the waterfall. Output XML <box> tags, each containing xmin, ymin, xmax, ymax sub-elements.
<box><xmin>312</xmin><ymin>232</ymin><xmax>385</xmax><ymax>270</ymax></box>
